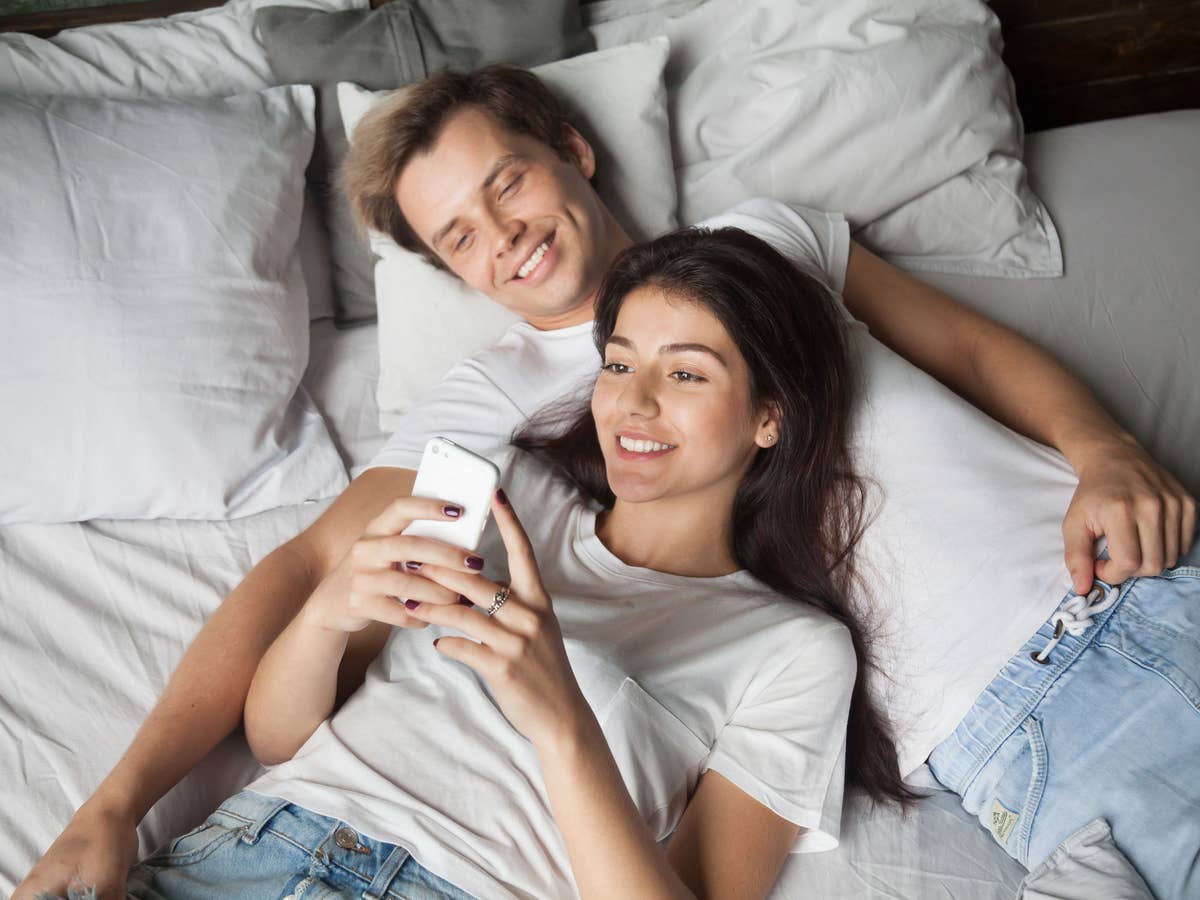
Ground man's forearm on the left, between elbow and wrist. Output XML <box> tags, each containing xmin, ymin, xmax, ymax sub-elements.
<box><xmin>94</xmin><ymin>545</ymin><xmax>317</xmax><ymax>822</ymax></box>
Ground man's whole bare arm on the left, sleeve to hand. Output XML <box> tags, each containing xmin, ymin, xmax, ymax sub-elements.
<box><xmin>14</xmin><ymin>468</ymin><xmax>424</xmax><ymax>899</ymax></box>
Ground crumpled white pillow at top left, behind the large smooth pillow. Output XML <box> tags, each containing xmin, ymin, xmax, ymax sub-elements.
<box><xmin>0</xmin><ymin>0</ymin><xmax>368</xmax><ymax>319</ymax></box>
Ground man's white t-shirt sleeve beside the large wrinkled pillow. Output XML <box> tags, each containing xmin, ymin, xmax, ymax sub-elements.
<box><xmin>700</xmin><ymin>198</ymin><xmax>850</xmax><ymax>294</ymax></box>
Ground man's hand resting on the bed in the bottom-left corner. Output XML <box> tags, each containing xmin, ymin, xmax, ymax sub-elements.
<box><xmin>13</xmin><ymin>799</ymin><xmax>138</xmax><ymax>900</ymax></box>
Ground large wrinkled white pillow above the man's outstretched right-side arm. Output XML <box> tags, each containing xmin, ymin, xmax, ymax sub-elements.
<box><xmin>583</xmin><ymin>0</ymin><xmax>1062</xmax><ymax>277</ymax></box>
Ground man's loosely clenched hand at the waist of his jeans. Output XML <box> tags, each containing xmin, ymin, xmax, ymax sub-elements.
<box><xmin>1062</xmin><ymin>438</ymin><xmax>1196</xmax><ymax>594</ymax></box>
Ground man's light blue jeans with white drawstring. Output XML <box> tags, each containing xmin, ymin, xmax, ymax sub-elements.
<box><xmin>929</xmin><ymin>544</ymin><xmax>1200</xmax><ymax>900</ymax></box>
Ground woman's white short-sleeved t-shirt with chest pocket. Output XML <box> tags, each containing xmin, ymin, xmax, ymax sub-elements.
<box><xmin>250</xmin><ymin>448</ymin><xmax>856</xmax><ymax>899</ymax></box>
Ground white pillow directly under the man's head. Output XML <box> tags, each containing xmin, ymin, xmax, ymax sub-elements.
<box><xmin>337</xmin><ymin>37</ymin><xmax>676</xmax><ymax>431</ymax></box>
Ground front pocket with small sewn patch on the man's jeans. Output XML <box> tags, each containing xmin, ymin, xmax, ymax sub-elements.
<box><xmin>967</xmin><ymin>716</ymin><xmax>1048</xmax><ymax>865</ymax></box>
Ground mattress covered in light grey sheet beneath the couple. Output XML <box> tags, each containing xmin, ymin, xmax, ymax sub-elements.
<box><xmin>0</xmin><ymin>112</ymin><xmax>1200</xmax><ymax>900</ymax></box>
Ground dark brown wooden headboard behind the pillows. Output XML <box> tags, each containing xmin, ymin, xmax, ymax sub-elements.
<box><xmin>0</xmin><ymin>0</ymin><xmax>1200</xmax><ymax>132</ymax></box>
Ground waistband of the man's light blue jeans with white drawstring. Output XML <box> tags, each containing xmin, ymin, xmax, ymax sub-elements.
<box><xmin>934</xmin><ymin>578</ymin><xmax>1138</xmax><ymax>794</ymax></box>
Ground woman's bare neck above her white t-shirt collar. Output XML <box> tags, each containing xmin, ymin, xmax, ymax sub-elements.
<box><xmin>596</xmin><ymin>497</ymin><xmax>742</xmax><ymax>578</ymax></box>
